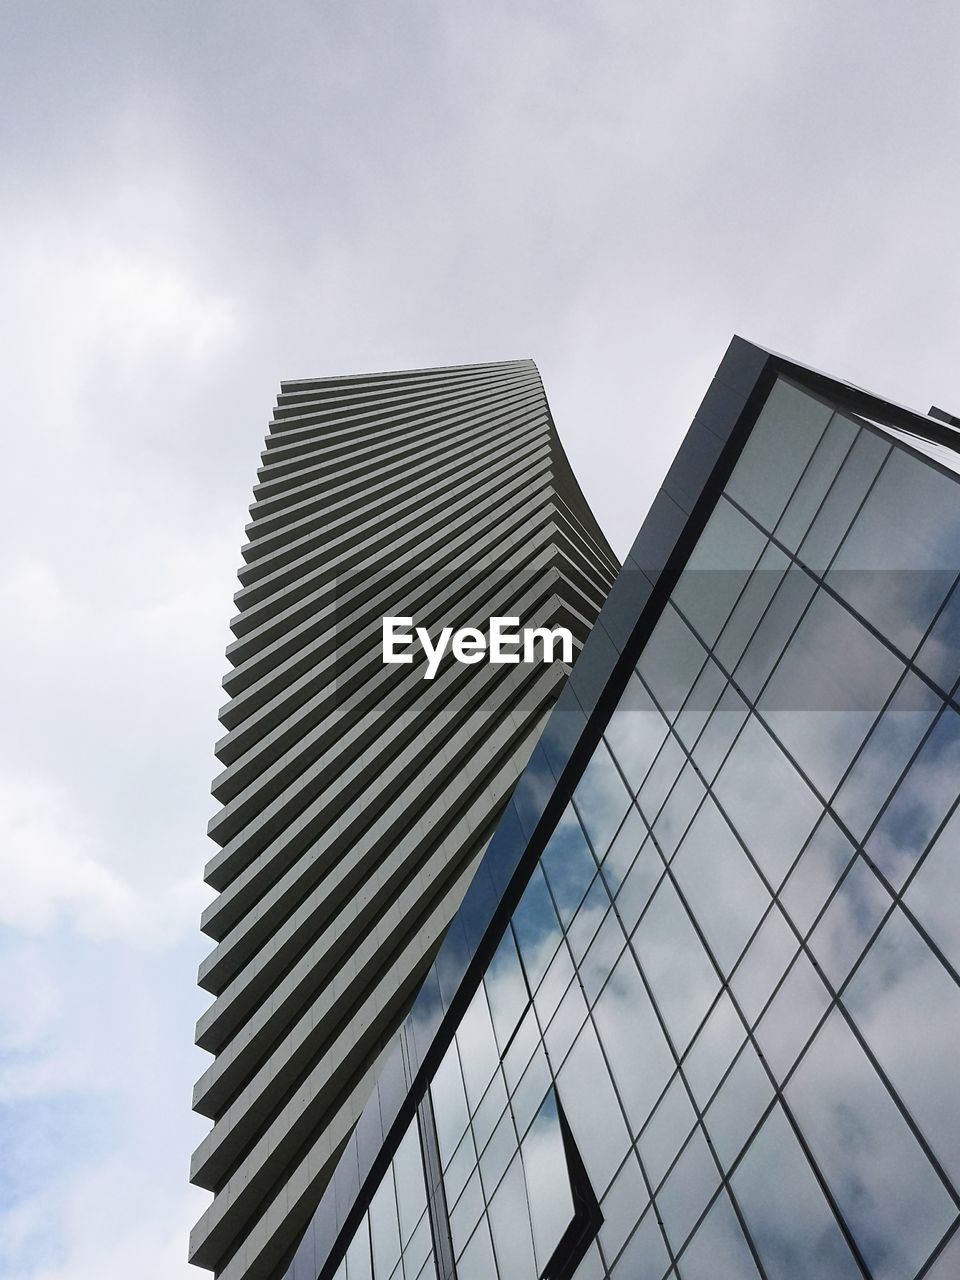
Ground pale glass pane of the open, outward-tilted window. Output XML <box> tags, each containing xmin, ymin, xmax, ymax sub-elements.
<box><xmin>557</xmin><ymin>1023</ymin><xmax>630</xmax><ymax>1198</ymax></box>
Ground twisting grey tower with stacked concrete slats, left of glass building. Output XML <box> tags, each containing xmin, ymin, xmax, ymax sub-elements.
<box><xmin>191</xmin><ymin>361</ymin><xmax>617</xmax><ymax>1280</ymax></box>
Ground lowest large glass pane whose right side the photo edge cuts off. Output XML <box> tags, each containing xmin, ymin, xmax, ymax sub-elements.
<box><xmin>844</xmin><ymin>900</ymin><xmax>960</xmax><ymax>1185</ymax></box>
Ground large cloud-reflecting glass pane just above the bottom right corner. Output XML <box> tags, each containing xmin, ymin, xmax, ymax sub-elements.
<box><xmin>786</xmin><ymin>1011</ymin><xmax>956</xmax><ymax>1280</ymax></box>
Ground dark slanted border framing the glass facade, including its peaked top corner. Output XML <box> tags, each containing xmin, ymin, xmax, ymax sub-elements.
<box><xmin>284</xmin><ymin>337</ymin><xmax>938</xmax><ymax>1280</ymax></box>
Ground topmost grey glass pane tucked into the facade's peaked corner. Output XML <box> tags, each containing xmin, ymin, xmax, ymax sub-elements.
<box><xmin>726</xmin><ymin>379</ymin><xmax>832</xmax><ymax>529</ymax></box>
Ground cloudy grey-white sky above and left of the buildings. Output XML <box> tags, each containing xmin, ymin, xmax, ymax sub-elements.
<box><xmin>0</xmin><ymin>0</ymin><xmax>960</xmax><ymax>1280</ymax></box>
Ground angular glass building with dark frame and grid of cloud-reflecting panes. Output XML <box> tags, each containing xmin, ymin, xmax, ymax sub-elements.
<box><xmin>276</xmin><ymin>339</ymin><xmax>960</xmax><ymax>1280</ymax></box>
